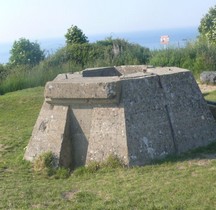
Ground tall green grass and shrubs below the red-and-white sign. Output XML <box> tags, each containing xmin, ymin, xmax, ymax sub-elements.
<box><xmin>150</xmin><ymin>40</ymin><xmax>216</xmax><ymax>78</ymax></box>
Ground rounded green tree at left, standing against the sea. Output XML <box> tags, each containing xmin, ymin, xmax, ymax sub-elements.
<box><xmin>9</xmin><ymin>38</ymin><xmax>45</xmax><ymax>66</ymax></box>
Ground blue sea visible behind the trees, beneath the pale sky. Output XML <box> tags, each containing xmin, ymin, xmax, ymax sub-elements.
<box><xmin>0</xmin><ymin>27</ymin><xmax>199</xmax><ymax>64</ymax></box>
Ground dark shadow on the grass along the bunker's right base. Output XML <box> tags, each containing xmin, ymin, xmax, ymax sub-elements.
<box><xmin>151</xmin><ymin>141</ymin><xmax>216</xmax><ymax>165</ymax></box>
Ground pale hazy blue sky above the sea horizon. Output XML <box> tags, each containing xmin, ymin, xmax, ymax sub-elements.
<box><xmin>0</xmin><ymin>0</ymin><xmax>216</xmax><ymax>43</ymax></box>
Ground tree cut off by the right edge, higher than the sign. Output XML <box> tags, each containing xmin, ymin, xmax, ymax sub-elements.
<box><xmin>198</xmin><ymin>5</ymin><xmax>216</xmax><ymax>44</ymax></box>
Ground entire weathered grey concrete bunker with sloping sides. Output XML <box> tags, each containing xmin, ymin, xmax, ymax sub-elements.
<box><xmin>25</xmin><ymin>66</ymin><xmax>216</xmax><ymax>168</ymax></box>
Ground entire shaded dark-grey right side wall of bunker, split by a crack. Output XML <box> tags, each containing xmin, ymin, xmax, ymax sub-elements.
<box><xmin>122</xmin><ymin>68</ymin><xmax>216</xmax><ymax>165</ymax></box>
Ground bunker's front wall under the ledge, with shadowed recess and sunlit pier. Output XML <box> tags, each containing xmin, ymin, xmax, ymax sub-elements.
<box><xmin>66</xmin><ymin>104</ymin><xmax>128</xmax><ymax>168</ymax></box>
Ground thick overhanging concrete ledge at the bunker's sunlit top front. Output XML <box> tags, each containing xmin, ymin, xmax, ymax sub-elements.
<box><xmin>45</xmin><ymin>77</ymin><xmax>121</xmax><ymax>104</ymax></box>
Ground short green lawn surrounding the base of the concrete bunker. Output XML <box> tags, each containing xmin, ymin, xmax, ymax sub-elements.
<box><xmin>0</xmin><ymin>88</ymin><xmax>216</xmax><ymax>210</ymax></box>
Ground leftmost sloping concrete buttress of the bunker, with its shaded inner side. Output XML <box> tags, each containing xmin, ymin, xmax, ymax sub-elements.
<box><xmin>24</xmin><ymin>102</ymin><xmax>71</xmax><ymax>167</ymax></box>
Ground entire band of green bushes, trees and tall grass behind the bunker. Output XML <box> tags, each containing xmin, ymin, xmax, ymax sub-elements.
<box><xmin>0</xmin><ymin>5</ymin><xmax>216</xmax><ymax>95</ymax></box>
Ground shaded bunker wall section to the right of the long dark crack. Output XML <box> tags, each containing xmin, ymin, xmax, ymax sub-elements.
<box><xmin>160</xmin><ymin>71</ymin><xmax>216</xmax><ymax>153</ymax></box>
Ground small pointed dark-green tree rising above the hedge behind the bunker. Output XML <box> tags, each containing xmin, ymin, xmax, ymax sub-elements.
<box><xmin>65</xmin><ymin>25</ymin><xmax>88</xmax><ymax>45</ymax></box>
